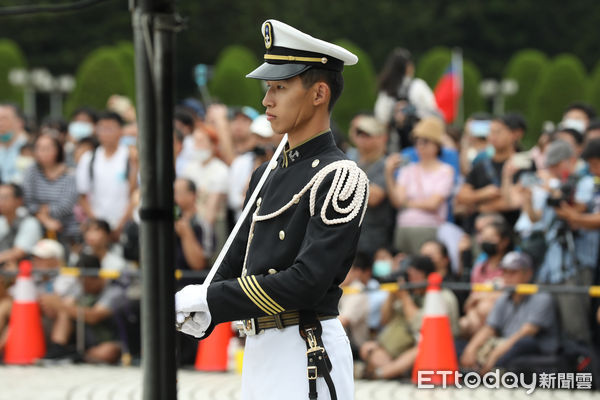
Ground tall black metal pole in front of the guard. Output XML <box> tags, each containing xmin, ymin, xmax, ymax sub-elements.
<box><xmin>131</xmin><ymin>0</ymin><xmax>177</xmax><ymax>400</ymax></box>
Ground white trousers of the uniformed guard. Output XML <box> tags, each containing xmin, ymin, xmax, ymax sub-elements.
<box><xmin>242</xmin><ymin>318</ymin><xmax>354</xmax><ymax>400</ymax></box>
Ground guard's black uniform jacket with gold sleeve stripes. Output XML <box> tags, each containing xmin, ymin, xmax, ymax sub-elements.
<box><xmin>207</xmin><ymin>131</ymin><xmax>368</xmax><ymax>326</ymax></box>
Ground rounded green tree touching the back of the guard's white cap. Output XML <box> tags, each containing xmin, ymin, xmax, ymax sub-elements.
<box><xmin>333</xmin><ymin>40</ymin><xmax>377</xmax><ymax>134</ymax></box>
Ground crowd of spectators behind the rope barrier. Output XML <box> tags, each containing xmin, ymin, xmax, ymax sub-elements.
<box><xmin>0</xmin><ymin>49</ymin><xmax>600</xmax><ymax>384</ymax></box>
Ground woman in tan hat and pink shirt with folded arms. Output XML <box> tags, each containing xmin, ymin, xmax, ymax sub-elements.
<box><xmin>385</xmin><ymin>117</ymin><xmax>454</xmax><ymax>254</ymax></box>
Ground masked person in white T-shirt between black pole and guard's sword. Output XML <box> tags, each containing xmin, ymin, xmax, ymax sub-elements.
<box><xmin>182</xmin><ymin>123</ymin><xmax>229</xmax><ymax>259</ymax></box>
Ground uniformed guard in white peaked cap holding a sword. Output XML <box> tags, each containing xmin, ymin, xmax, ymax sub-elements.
<box><xmin>176</xmin><ymin>20</ymin><xmax>368</xmax><ymax>400</ymax></box>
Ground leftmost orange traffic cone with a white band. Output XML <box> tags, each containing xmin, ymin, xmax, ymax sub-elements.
<box><xmin>4</xmin><ymin>260</ymin><xmax>46</xmax><ymax>364</ymax></box>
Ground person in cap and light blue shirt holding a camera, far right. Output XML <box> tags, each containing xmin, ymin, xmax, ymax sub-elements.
<box><xmin>524</xmin><ymin>140</ymin><xmax>600</xmax><ymax>343</ymax></box>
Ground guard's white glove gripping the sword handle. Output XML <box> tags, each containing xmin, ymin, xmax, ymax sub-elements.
<box><xmin>175</xmin><ymin>285</ymin><xmax>211</xmax><ymax>337</ymax></box>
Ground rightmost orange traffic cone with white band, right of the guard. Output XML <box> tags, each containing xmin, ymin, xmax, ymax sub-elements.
<box><xmin>412</xmin><ymin>272</ymin><xmax>458</xmax><ymax>385</ymax></box>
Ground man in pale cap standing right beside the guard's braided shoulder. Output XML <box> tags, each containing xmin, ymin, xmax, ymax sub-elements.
<box><xmin>350</xmin><ymin>114</ymin><xmax>394</xmax><ymax>257</ymax></box>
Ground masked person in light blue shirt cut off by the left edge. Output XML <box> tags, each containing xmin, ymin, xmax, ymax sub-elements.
<box><xmin>0</xmin><ymin>104</ymin><xmax>27</xmax><ymax>183</ymax></box>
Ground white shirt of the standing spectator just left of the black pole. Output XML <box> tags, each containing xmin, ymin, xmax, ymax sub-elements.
<box><xmin>76</xmin><ymin>146</ymin><xmax>129</xmax><ymax>228</ymax></box>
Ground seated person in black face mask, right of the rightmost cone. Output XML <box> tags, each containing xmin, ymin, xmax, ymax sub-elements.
<box><xmin>459</xmin><ymin>222</ymin><xmax>513</xmax><ymax>338</ymax></box>
